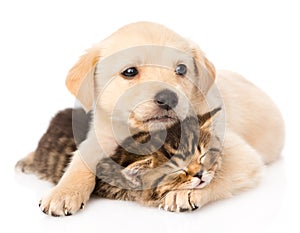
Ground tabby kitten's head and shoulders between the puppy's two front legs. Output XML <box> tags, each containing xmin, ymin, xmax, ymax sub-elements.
<box><xmin>94</xmin><ymin>108</ymin><xmax>221</xmax><ymax>211</ymax></box>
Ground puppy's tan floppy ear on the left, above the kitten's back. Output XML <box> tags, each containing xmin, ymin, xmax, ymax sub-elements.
<box><xmin>66</xmin><ymin>47</ymin><xmax>100</xmax><ymax>112</ymax></box>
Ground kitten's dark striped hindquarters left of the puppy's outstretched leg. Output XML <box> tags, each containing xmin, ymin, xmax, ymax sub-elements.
<box><xmin>16</xmin><ymin>108</ymin><xmax>90</xmax><ymax>184</ymax></box>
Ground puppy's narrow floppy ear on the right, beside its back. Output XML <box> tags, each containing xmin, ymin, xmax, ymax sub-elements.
<box><xmin>191</xmin><ymin>42</ymin><xmax>216</xmax><ymax>94</ymax></box>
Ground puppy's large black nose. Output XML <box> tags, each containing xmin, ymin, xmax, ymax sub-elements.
<box><xmin>154</xmin><ymin>89</ymin><xmax>178</xmax><ymax>110</ymax></box>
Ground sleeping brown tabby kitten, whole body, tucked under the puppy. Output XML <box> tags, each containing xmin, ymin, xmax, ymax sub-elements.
<box><xmin>16</xmin><ymin>108</ymin><xmax>221</xmax><ymax>213</ymax></box>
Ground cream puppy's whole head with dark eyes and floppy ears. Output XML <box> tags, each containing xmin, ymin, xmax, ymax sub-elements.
<box><xmin>66</xmin><ymin>22</ymin><xmax>215</xmax><ymax>130</ymax></box>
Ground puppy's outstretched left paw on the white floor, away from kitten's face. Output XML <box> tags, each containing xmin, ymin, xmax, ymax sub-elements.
<box><xmin>39</xmin><ymin>186</ymin><xmax>89</xmax><ymax>217</ymax></box>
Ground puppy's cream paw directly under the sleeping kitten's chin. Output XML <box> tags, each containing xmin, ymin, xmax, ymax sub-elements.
<box><xmin>159</xmin><ymin>190</ymin><xmax>200</xmax><ymax>212</ymax></box>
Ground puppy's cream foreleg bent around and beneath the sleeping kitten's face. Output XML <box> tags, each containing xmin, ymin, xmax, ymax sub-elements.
<box><xmin>160</xmin><ymin>132</ymin><xmax>263</xmax><ymax>212</ymax></box>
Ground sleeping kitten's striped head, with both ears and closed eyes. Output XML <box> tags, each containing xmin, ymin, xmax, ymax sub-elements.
<box><xmin>122</xmin><ymin>109</ymin><xmax>221</xmax><ymax>193</ymax></box>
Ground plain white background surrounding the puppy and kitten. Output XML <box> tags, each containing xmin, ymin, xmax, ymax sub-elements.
<box><xmin>0</xmin><ymin>0</ymin><xmax>300</xmax><ymax>233</ymax></box>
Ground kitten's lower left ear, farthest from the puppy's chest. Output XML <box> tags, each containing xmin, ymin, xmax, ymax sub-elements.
<box><xmin>122</xmin><ymin>157</ymin><xmax>153</xmax><ymax>187</ymax></box>
